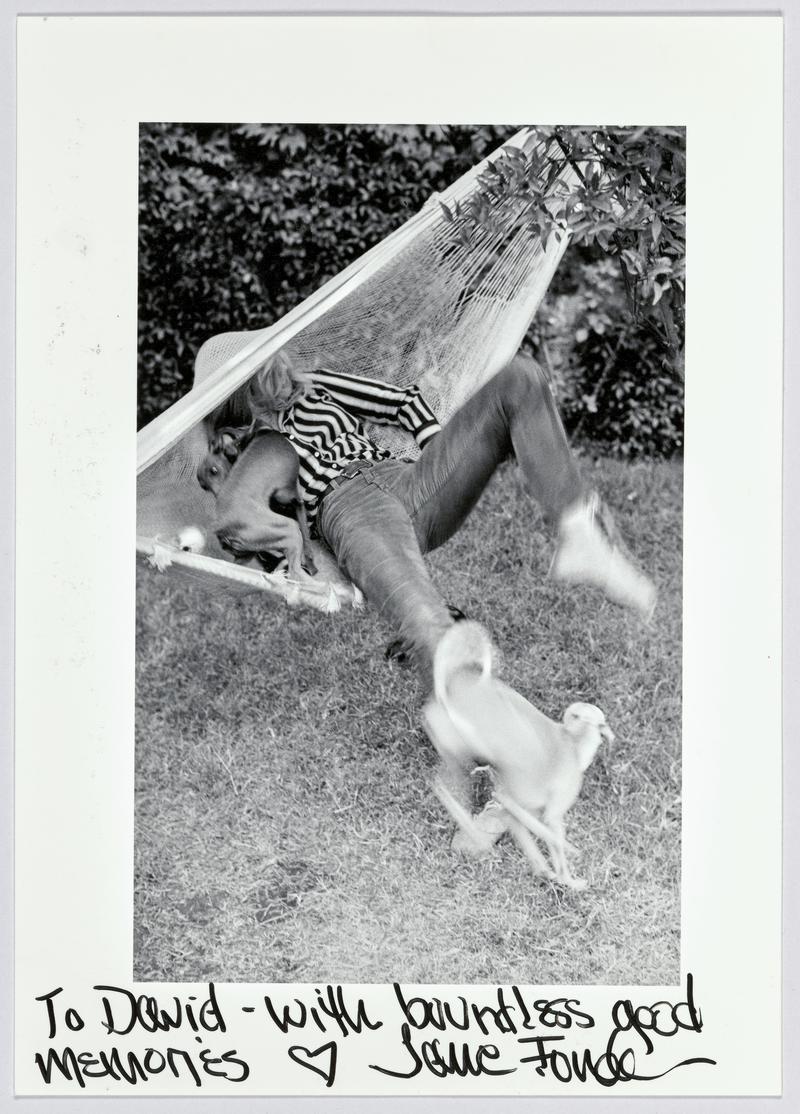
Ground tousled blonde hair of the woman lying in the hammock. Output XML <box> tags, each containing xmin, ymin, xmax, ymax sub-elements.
<box><xmin>207</xmin><ymin>349</ymin><xmax>312</xmax><ymax>433</ymax></box>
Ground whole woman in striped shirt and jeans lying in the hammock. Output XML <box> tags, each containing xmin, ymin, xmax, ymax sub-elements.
<box><xmin>208</xmin><ymin>352</ymin><xmax>655</xmax><ymax>674</ymax></box>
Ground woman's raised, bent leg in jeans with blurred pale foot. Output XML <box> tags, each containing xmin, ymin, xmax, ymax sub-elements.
<box><xmin>402</xmin><ymin>355</ymin><xmax>655</xmax><ymax>614</ymax></box>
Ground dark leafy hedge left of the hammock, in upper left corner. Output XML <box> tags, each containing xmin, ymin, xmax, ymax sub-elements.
<box><xmin>139</xmin><ymin>124</ymin><xmax>514</xmax><ymax>423</ymax></box>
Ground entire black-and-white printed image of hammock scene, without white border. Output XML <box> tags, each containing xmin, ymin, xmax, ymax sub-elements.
<box><xmin>130</xmin><ymin>119</ymin><xmax>686</xmax><ymax>987</ymax></box>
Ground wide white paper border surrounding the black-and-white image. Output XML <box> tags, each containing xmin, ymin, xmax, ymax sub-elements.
<box><xmin>14</xmin><ymin>17</ymin><xmax>782</xmax><ymax>1096</ymax></box>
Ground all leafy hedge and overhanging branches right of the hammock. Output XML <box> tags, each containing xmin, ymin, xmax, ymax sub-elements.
<box><xmin>448</xmin><ymin>127</ymin><xmax>685</xmax><ymax>456</ymax></box>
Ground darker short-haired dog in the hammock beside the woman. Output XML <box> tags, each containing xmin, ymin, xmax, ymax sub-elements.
<box><xmin>205</xmin><ymin>430</ymin><xmax>316</xmax><ymax>579</ymax></box>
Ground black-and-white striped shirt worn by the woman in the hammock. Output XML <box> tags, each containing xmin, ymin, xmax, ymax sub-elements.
<box><xmin>279</xmin><ymin>370</ymin><xmax>441</xmax><ymax>520</ymax></box>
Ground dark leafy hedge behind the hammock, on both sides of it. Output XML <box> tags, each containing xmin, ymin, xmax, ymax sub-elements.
<box><xmin>139</xmin><ymin>124</ymin><xmax>683</xmax><ymax>456</ymax></box>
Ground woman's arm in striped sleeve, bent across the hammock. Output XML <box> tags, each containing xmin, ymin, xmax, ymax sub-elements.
<box><xmin>311</xmin><ymin>370</ymin><xmax>441</xmax><ymax>448</ymax></box>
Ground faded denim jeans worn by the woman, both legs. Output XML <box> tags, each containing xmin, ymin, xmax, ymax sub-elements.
<box><xmin>318</xmin><ymin>355</ymin><xmax>585</xmax><ymax>673</ymax></box>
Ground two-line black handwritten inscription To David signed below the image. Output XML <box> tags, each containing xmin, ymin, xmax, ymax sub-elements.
<box><xmin>35</xmin><ymin>975</ymin><xmax>715</xmax><ymax>1092</ymax></box>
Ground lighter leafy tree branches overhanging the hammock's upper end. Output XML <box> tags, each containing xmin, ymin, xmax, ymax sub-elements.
<box><xmin>442</xmin><ymin>127</ymin><xmax>686</xmax><ymax>370</ymax></box>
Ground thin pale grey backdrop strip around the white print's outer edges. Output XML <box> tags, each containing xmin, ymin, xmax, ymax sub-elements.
<box><xmin>0</xmin><ymin>0</ymin><xmax>800</xmax><ymax>1114</ymax></box>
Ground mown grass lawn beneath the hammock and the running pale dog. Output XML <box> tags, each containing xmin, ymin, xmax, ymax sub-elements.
<box><xmin>134</xmin><ymin>458</ymin><xmax>683</xmax><ymax>985</ymax></box>
